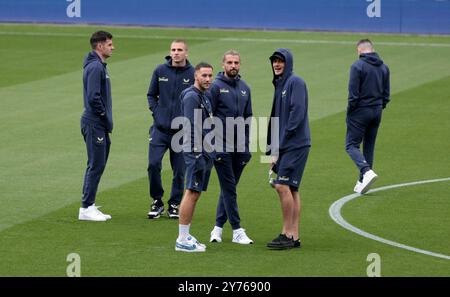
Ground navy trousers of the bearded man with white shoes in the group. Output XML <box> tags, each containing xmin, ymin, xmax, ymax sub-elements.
<box><xmin>214</xmin><ymin>153</ymin><xmax>251</xmax><ymax>230</ymax></box>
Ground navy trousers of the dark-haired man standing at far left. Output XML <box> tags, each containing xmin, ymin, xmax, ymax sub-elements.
<box><xmin>81</xmin><ymin>123</ymin><xmax>111</xmax><ymax>208</ymax></box>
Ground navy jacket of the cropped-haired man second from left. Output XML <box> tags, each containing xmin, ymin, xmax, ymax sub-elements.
<box><xmin>147</xmin><ymin>56</ymin><xmax>195</xmax><ymax>133</ymax></box>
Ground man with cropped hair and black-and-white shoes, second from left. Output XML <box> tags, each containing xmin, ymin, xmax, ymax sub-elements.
<box><xmin>147</xmin><ymin>40</ymin><xmax>194</xmax><ymax>219</ymax></box>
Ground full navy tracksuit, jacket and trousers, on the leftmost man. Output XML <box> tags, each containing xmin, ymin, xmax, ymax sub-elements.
<box><xmin>80</xmin><ymin>51</ymin><xmax>113</xmax><ymax>208</ymax></box>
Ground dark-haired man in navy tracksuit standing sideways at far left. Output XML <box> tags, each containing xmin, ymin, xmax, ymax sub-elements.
<box><xmin>78</xmin><ymin>31</ymin><xmax>114</xmax><ymax>221</ymax></box>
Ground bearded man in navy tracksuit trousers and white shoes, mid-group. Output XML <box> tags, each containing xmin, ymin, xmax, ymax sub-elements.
<box><xmin>208</xmin><ymin>50</ymin><xmax>253</xmax><ymax>244</ymax></box>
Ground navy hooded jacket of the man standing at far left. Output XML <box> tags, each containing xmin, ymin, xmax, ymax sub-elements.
<box><xmin>81</xmin><ymin>51</ymin><xmax>113</xmax><ymax>132</ymax></box>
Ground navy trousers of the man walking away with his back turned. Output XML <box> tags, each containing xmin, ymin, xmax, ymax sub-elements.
<box><xmin>345</xmin><ymin>106</ymin><xmax>383</xmax><ymax>181</ymax></box>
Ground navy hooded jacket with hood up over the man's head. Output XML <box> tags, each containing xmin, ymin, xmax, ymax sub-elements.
<box><xmin>266</xmin><ymin>48</ymin><xmax>311</xmax><ymax>155</ymax></box>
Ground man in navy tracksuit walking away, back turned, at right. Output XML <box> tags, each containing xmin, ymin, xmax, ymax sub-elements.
<box><xmin>345</xmin><ymin>39</ymin><xmax>390</xmax><ymax>194</ymax></box>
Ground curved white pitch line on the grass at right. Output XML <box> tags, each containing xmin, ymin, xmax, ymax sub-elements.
<box><xmin>328</xmin><ymin>177</ymin><xmax>450</xmax><ymax>260</ymax></box>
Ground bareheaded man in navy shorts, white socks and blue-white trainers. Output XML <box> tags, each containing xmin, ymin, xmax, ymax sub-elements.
<box><xmin>175</xmin><ymin>62</ymin><xmax>214</xmax><ymax>252</ymax></box>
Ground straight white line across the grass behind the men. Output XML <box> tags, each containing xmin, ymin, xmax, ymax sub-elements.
<box><xmin>0</xmin><ymin>31</ymin><xmax>450</xmax><ymax>47</ymax></box>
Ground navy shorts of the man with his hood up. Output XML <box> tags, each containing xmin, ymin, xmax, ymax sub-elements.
<box><xmin>273</xmin><ymin>146</ymin><xmax>310</xmax><ymax>192</ymax></box>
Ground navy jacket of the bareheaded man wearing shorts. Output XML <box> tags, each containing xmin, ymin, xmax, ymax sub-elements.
<box><xmin>180</xmin><ymin>86</ymin><xmax>213</xmax><ymax>155</ymax></box>
